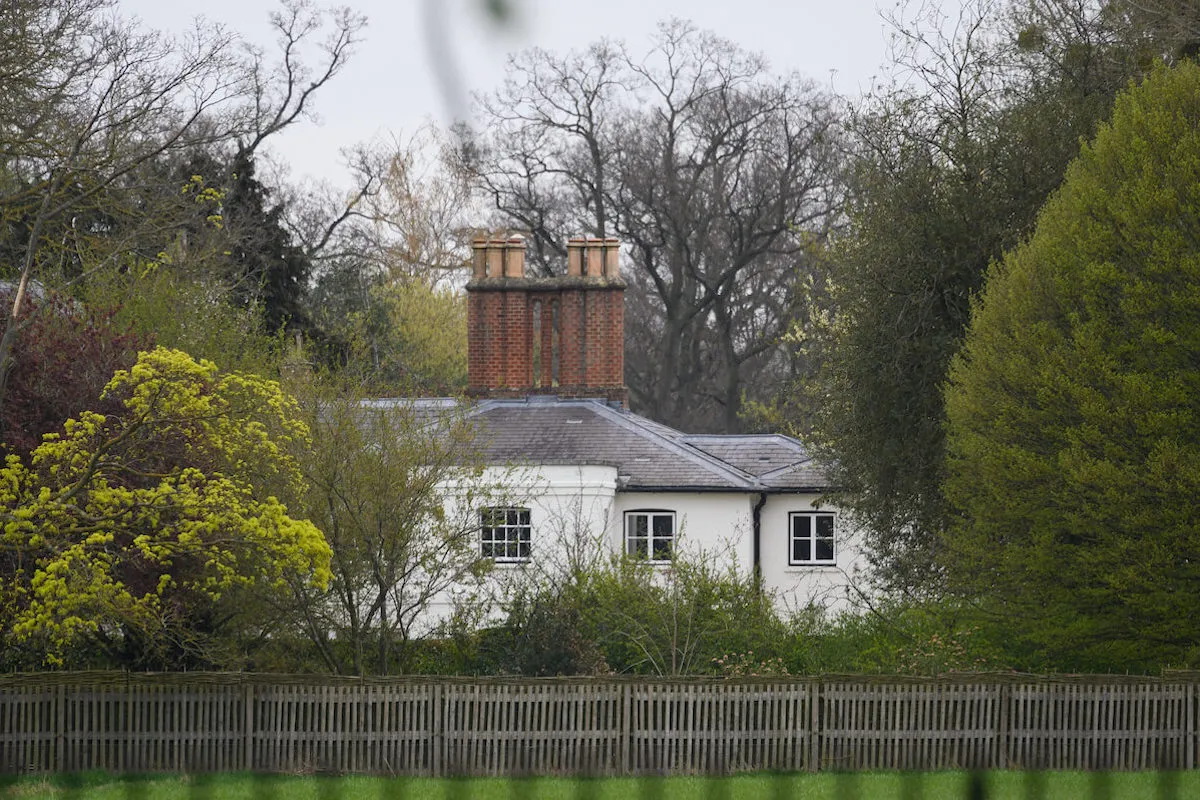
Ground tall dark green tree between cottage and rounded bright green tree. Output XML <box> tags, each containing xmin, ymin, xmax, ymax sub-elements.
<box><xmin>788</xmin><ymin>0</ymin><xmax>1182</xmax><ymax>590</ymax></box>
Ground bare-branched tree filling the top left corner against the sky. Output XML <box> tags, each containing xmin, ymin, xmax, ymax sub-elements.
<box><xmin>0</xmin><ymin>0</ymin><xmax>364</xmax><ymax>422</ymax></box>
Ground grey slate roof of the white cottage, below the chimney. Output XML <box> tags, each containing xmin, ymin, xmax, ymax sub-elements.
<box><xmin>388</xmin><ymin>396</ymin><xmax>829</xmax><ymax>492</ymax></box>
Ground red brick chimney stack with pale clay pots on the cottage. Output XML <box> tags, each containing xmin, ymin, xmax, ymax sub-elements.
<box><xmin>467</xmin><ymin>236</ymin><xmax>629</xmax><ymax>404</ymax></box>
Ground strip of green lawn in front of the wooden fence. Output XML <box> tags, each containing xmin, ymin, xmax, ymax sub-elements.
<box><xmin>0</xmin><ymin>771</ymin><xmax>1200</xmax><ymax>800</ymax></box>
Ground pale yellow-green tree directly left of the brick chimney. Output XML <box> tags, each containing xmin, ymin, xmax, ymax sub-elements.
<box><xmin>304</xmin><ymin>128</ymin><xmax>478</xmax><ymax>397</ymax></box>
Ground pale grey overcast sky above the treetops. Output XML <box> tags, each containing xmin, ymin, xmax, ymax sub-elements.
<box><xmin>119</xmin><ymin>0</ymin><xmax>936</xmax><ymax>184</ymax></box>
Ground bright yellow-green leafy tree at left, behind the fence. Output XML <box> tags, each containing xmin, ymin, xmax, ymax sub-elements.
<box><xmin>0</xmin><ymin>348</ymin><xmax>330</xmax><ymax>668</ymax></box>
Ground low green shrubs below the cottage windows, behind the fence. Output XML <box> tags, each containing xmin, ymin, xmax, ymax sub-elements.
<box><xmin>456</xmin><ymin>559</ymin><xmax>1025</xmax><ymax>678</ymax></box>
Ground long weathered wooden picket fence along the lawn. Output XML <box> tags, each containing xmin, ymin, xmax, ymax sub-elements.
<box><xmin>0</xmin><ymin>673</ymin><xmax>1200</xmax><ymax>775</ymax></box>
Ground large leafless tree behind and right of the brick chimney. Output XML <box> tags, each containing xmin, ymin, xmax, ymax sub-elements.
<box><xmin>460</xmin><ymin>20</ymin><xmax>840</xmax><ymax>431</ymax></box>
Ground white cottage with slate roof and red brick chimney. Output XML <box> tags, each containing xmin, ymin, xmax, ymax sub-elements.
<box><xmin>417</xmin><ymin>239</ymin><xmax>859</xmax><ymax>609</ymax></box>
